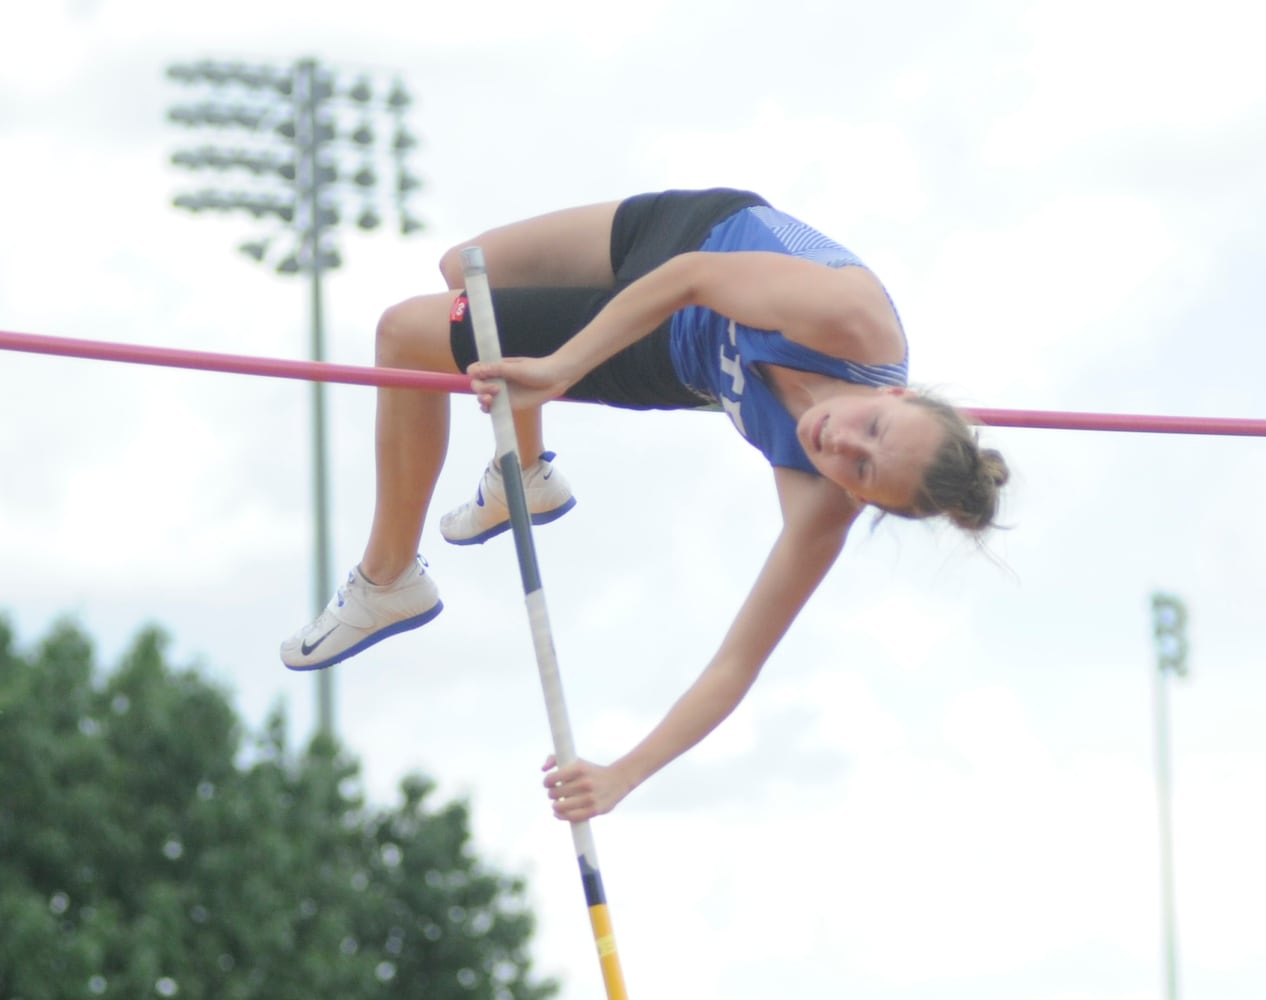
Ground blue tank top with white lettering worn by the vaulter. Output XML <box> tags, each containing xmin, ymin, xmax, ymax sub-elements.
<box><xmin>668</xmin><ymin>205</ymin><xmax>909</xmax><ymax>475</ymax></box>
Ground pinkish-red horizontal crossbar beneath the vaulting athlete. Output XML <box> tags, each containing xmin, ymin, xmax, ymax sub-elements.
<box><xmin>0</xmin><ymin>330</ymin><xmax>1266</xmax><ymax>438</ymax></box>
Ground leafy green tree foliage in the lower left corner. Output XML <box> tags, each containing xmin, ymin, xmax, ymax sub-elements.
<box><xmin>0</xmin><ymin>618</ymin><xmax>557</xmax><ymax>1000</ymax></box>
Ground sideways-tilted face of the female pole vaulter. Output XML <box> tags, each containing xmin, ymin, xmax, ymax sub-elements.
<box><xmin>796</xmin><ymin>390</ymin><xmax>944</xmax><ymax>510</ymax></box>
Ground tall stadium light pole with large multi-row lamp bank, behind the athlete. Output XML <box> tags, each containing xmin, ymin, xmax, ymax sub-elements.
<box><xmin>167</xmin><ymin>59</ymin><xmax>422</xmax><ymax>735</ymax></box>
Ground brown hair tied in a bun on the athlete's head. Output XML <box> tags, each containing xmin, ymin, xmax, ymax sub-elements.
<box><xmin>887</xmin><ymin>391</ymin><xmax>1010</xmax><ymax>534</ymax></box>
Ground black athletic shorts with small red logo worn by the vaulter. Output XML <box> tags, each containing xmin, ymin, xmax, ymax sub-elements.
<box><xmin>449</xmin><ymin>187</ymin><xmax>767</xmax><ymax>410</ymax></box>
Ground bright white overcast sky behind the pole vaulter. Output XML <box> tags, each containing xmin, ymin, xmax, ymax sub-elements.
<box><xmin>0</xmin><ymin>0</ymin><xmax>1266</xmax><ymax>1000</ymax></box>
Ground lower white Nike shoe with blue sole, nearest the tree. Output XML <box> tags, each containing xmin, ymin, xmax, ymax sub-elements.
<box><xmin>281</xmin><ymin>556</ymin><xmax>444</xmax><ymax>670</ymax></box>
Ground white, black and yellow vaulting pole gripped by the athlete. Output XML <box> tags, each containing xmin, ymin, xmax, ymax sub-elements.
<box><xmin>462</xmin><ymin>247</ymin><xmax>628</xmax><ymax>1000</ymax></box>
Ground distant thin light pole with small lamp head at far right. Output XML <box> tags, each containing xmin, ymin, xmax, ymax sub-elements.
<box><xmin>1152</xmin><ymin>594</ymin><xmax>1188</xmax><ymax>1000</ymax></box>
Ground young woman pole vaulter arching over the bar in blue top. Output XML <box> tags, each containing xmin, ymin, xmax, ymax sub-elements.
<box><xmin>281</xmin><ymin>189</ymin><xmax>1008</xmax><ymax>820</ymax></box>
